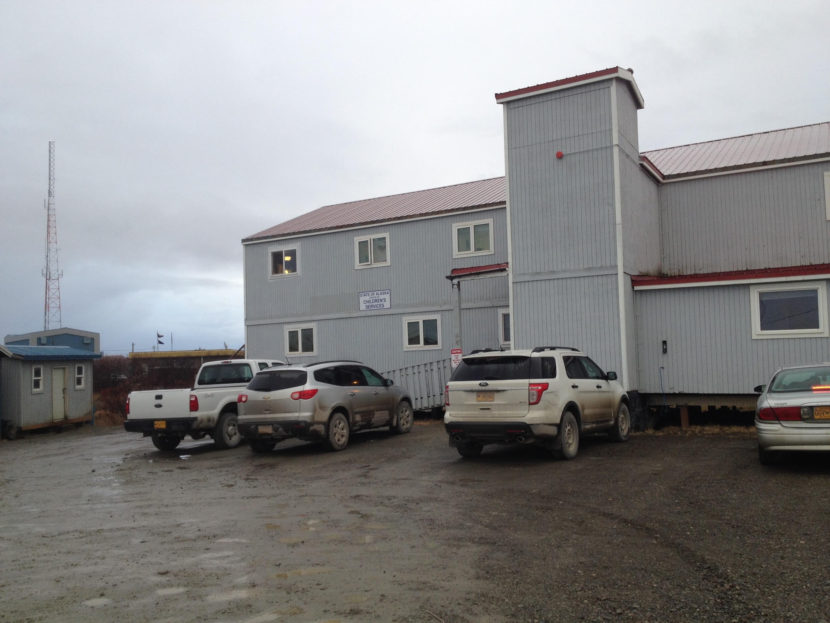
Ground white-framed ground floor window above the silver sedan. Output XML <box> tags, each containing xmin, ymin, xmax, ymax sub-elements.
<box><xmin>750</xmin><ymin>282</ymin><xmax>828</xmax><ymax>339</ymax></box>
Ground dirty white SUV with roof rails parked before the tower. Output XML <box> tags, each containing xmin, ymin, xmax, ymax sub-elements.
<box><xmin>444</xmin><ymin>346</ymin><xmax>631</xmax><ymax>459</ymax></box>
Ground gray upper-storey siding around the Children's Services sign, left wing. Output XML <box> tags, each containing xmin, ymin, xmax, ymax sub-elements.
<box><xmin>244</xmin><ymin>209</ymin><xmax>507</xmax><ymax>324</ymax></box>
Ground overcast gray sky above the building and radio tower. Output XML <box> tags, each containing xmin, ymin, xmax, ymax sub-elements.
<box><xmin>0</xmin><ymin>0</ymin><xmax>830</xmax><ymax>354</ymax></box>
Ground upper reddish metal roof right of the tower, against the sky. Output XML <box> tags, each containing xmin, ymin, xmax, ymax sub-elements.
<box><xmin>641</xmin><ymin>122</ymin><xmax>830</xmax><ymax>180</ymax></box>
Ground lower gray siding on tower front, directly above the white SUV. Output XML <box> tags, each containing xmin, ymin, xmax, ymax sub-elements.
<box><xmin>513</xmin><ymin>275</ymin><xmax>622</xmax><ymax>373</ymax></box>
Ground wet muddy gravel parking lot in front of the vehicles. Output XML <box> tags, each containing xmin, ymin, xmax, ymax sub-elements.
<box><xmin>0</xmin><ymin>420</ymin><xmax>830</xmax><ymax>623</ymax></box>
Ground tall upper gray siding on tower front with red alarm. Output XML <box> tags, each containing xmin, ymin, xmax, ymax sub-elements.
<box><xmin>506</xmin><ymin>84</ymin><xmax>616</xmax><ymax>276</ymax></box>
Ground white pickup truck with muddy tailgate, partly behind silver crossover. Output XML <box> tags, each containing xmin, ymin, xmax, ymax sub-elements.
<box><xmin>124</xmin><ymin>359</ymin><xmax>285</xmax><ymax>450</ymax></box>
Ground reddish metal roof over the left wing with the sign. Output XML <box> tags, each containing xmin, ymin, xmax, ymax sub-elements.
<box><xmin>242</xmin><ymin>177</ymin><xmax>506</xmax><ymax>242</ymax></box>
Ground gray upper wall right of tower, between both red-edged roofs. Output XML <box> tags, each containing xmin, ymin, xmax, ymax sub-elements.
<box><xmin>660</xmin><ymin>164</ymin><xmax>830</xmax><ymax>275</ymax></box>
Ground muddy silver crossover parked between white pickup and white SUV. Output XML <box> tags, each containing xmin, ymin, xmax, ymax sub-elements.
<box><xmin>237</xmin><ymin>361</ymin><xmax>414</xmax><ymax>452</ymax></box>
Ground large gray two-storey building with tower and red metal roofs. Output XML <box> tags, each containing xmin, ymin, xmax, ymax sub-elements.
<box><xmin>242</xmin><ymin>67</ymin><xmax>830</xmax><ymax>405</ymax></box>
